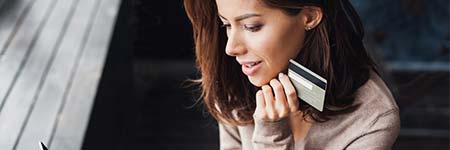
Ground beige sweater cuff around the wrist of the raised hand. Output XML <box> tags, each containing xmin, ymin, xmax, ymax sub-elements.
<box><xmin>252</xmin><ymin>117</ymin><xmax>295</xmax><ymax>150</ymax></box>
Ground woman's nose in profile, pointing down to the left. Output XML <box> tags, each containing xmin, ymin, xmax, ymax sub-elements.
<box><xmin>225</xmin><ymin>32</ymin><xmax>246</xmax><ymax>56</ymax></box>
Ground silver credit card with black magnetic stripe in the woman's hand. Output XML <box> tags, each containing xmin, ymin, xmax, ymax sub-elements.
<box><xmin>288</xmin><ymin>59</ymin><xmax>327</xmax><ymax>111</ymax></box>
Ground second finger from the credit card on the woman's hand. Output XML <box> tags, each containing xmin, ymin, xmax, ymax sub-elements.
<box><xmin>270</xmin><ymin>79</ymin><xmax>290</xmax><ymax>118</ymax></box>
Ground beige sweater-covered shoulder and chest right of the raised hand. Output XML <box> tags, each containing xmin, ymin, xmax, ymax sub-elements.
<box><xmin>305</xmin><ymin>72</ymin><xmax>400</xmax><ymax>149</ymax></box>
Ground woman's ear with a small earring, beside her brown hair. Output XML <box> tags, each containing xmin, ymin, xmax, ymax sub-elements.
<box><xmin>301</xmin><ymin>6</ymin><xmax>323</xmax><ymax>30</ymax></box>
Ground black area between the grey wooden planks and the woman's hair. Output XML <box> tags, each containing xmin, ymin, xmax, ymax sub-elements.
<box><xmin>83</xmin><ymin>0</ymin><xmax>218</xmax><ymax>150</ymax></box>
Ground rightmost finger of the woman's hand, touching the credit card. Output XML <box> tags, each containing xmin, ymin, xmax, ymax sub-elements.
<box><xmin>278</xmin><ymin>73</ymin><xmax>298</xmax><ymax>112</ymax></box>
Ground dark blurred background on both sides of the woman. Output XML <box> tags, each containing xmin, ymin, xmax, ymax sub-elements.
<box><xmin>83</xmin><ymin>0</ymin><xmax>450</xmax><ymax>150</ymax></box>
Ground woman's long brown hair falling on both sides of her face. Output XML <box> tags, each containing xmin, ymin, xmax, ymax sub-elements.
<box><xmin>184</xmin><ymin>0</ymin><xmax>377</xmax><ymax>125</ymax></box>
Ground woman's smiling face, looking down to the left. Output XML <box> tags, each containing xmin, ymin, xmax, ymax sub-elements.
<box><xmin>216</xmin><ymin>0</ymin><xmax>306</xmax><ymax>86</ymax></box>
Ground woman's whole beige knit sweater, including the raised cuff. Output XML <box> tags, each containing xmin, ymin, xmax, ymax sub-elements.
<box><xmin>219</xmin><ymin>72</ymin><xmax>400</xmax><ymax>150</ymax></box>
